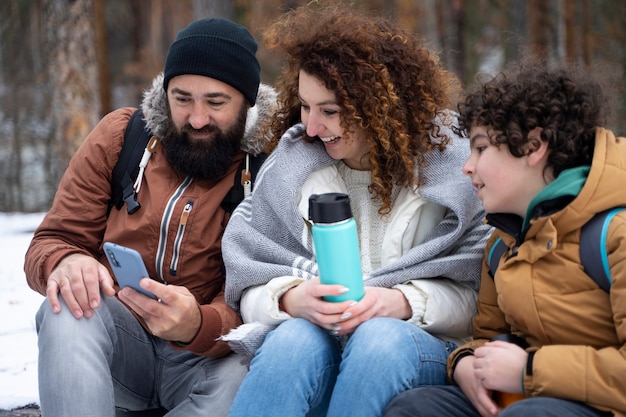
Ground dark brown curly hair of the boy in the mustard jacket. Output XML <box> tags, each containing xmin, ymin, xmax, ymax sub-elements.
<box><xmin>459</xmin><ymin>63</ymin><xmax>607</xmax><ymax>178</ymax></box>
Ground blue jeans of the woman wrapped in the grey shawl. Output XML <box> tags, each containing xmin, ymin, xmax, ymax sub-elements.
<box><xmin>229</xmin><ymin>318</ymin><xmax>456</xmax><ymax>417</ymax></box>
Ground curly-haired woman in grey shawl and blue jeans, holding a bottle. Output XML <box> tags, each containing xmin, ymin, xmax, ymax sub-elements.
<box><xmin>223</xmin><ymin>5</ymin><xmax>491</xmax><ymax>417</ymax></box>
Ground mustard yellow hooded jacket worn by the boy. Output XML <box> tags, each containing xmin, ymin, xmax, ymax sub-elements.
<box><xmin>448</xmin><ymin>128</ymin><xmax>626</xmax><ymax>416</ymax></box>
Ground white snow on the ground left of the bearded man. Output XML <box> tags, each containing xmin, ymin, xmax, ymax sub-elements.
<box><xmin>0</xmin><ymin>213</ymin><xmax>44</xmax><ymax>410</ymax></box>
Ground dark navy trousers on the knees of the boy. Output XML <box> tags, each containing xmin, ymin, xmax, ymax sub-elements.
<box><xmin>384</xmin><ymin>385</ymin><xmax>613</xmax><ymax>417</ymax></box>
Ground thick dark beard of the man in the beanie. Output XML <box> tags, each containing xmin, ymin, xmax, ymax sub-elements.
<box><xmin>161</xmin><ymin>106</ymin><xmax>248</xmax><ymax>179</ymax></box>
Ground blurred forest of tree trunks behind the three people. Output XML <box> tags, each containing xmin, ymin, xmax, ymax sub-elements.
<box><xmin>0</xmin><ymin>0</ymin><xmax>626</xmax><ymax>212</ymax></box>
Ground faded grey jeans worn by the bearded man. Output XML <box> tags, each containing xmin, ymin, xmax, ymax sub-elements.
<box><xmin>37</xmin><ymin>297</ymin><xmax>246</xmax><ymax>417</ymax></box>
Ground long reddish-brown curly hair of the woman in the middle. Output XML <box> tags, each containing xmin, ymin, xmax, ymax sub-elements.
<box><xmin>264</xmin><ymin>2</ymin><xmax>460</xmax><ymax>215</ymax></box>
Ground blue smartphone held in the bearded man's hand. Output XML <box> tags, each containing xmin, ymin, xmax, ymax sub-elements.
<box><xmin>104</xmin><ymin>242</ymin><xmax>157</xmax><ymax>300</ymax></box>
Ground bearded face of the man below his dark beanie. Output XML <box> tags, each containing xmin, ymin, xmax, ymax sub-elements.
<box><xmin>162</xmin><ymin>75</ymin><xmax>248</xmax><ymax>179</ymax></box>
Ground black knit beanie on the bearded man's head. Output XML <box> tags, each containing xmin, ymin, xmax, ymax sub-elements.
<box><xmin>163</xmin><ymin>18</ymin><xmax>261</xmax><ymax>105</ymax></box>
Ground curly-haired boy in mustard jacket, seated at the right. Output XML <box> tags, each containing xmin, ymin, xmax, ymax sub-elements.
<box><xmin>385</xmin><ymin>61</ymin><xmax>626</xmax><ymax>417</ymax></box>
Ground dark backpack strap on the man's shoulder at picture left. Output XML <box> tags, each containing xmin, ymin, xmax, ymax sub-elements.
<box><xmin>109</xmin><ymin>109</ymin><xmax>152</xmax><ymax>214</ymax></box>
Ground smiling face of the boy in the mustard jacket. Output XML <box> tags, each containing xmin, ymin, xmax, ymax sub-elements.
<box><xmin>463</xmin><ymin>126</ymin><xmax>543</xmax><ymax>217</ymax></box>
